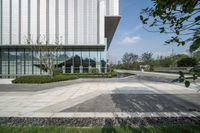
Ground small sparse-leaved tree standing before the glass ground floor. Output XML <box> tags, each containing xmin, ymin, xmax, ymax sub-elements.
<box><xmin>25</xmin><ymin>36</ymin><xmax>62</xmax><ymax>77</ymax></box>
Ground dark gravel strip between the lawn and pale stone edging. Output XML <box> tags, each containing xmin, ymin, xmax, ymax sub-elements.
<box><xmin>0</xmin><ymin>117</ymin><xmax>200</xmax><ymax>127</ymax></box>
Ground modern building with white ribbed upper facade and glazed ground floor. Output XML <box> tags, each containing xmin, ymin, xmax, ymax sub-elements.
<box><xmin>0</xmin><ymin>0</ymin><xmax>120</xmax><ymax>78</ymax></box>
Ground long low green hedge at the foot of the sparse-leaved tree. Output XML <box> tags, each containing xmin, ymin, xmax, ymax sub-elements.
<box><xmin>12</xmin><ymin>75</ymin><xmax>78</xmax><ymax>84</ymax></box>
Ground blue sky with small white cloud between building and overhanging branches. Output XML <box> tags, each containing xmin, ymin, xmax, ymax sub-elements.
<box><xmin>109</xmin><ymin>0</ymin><xmax>188</xmax><ymax>60</ymax></box>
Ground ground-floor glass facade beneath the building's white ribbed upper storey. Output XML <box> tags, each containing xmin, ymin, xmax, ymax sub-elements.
<box><xmin>0</xmin><ymin>48</ymin><xmax>106</xmax><ymax>78</ymax></box>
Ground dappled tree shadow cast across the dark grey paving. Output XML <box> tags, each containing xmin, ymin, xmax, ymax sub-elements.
<box><xmin>111</xmin><ymin>87</ymin><xmax>200</xmax><ymax>112</ymax></box>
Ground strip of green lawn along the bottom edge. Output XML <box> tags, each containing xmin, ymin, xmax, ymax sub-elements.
<box><xmin>0</xmin><ymin>125</ymin><xmax>200</xmax><ymax>133</ymax></box>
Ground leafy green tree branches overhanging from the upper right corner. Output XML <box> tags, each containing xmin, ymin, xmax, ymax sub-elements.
<box><xmin>140</xmin><ymin>0</ymin><xmax>200</xmax><ymax>51</ymax></box>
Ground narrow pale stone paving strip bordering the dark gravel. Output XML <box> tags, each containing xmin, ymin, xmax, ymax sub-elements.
<box><xmin>0</xmin><ymin>111</ymin><xmax>200</xmax><ymax>119</ymax></box>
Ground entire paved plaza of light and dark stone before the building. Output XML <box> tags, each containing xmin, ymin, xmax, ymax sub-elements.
<box><xmin>0</xmin><ymin>72</ymin><xmax>200</xmax><ymax>118</ymax></box>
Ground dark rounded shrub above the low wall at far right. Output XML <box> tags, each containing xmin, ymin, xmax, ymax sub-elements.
<box><xmin>177</xmin><ymin>58</ymin><xmax>197</xmax><ymax>67</ymax></box>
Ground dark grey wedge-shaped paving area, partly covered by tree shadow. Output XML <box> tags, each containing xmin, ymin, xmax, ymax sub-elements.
<box><xmin>62</xmin><ymin>94</ymin><xmax>200</xmax><ymax>112</ymax></box>
